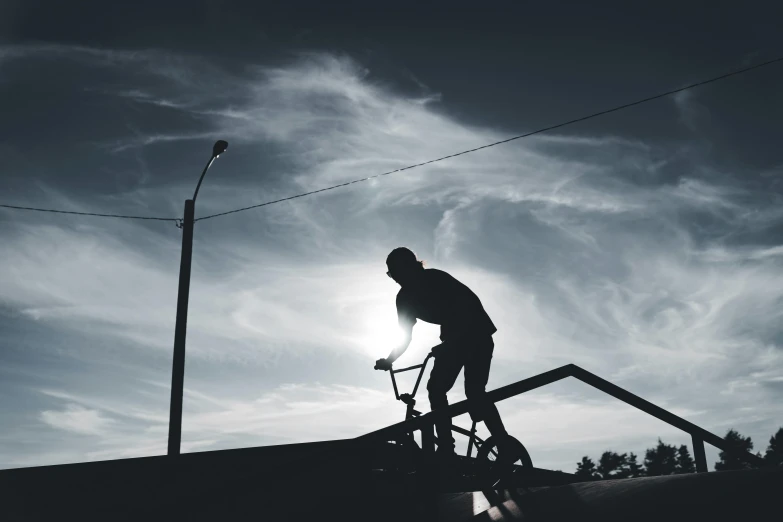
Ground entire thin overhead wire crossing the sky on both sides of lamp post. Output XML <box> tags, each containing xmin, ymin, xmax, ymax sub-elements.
<box><xmin>0</xmin><ymin>57</ymin><xmax>783</xmax><ymax>222</ymax></box>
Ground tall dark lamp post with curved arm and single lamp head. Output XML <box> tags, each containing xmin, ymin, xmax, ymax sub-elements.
<box><xmin>168</xmin><ymin>140</ymin><xmax>228</xmax><ymax>456</ymax></box>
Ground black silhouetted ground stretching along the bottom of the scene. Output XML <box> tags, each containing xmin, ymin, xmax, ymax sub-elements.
<box><xmin>0</xmin><ymin>441</ymin><xmax>783</xmax><ymax>522</ymax></box>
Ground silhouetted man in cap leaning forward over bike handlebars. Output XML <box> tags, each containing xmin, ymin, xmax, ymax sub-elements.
<box><xmin>375</xmin><ymin>247</ymin><xmax>511</xmax><ymax>461</ymax></box>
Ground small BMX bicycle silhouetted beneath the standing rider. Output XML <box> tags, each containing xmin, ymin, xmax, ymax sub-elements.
<box><xmin>376</xmin><ymin>345</ymin><xmax>533</xmax><ymax>485</ymax></box>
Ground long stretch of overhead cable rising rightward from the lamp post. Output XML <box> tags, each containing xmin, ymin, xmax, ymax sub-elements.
<box><xmin>195</xmin><ymin>57</ymin><xmax>783</xmax><ymax>221</ymax></box>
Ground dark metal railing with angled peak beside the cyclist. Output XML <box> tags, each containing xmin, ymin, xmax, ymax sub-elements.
<box><xmin>356</xmin><ymin>364</ymin><xmax>764</xmax><ymax>473</ymax></box>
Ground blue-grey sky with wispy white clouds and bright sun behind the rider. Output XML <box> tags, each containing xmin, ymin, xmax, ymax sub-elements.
<box><xmin>0</xmin><ymin>0</ymin><xmax>783</xmax><ymax>472</ymax></box>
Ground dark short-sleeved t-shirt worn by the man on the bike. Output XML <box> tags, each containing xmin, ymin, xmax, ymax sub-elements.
<box><xmin>397</xmin><ymin>268</ymin><xmax>497</xmax><ymax>341</ymax></box>
